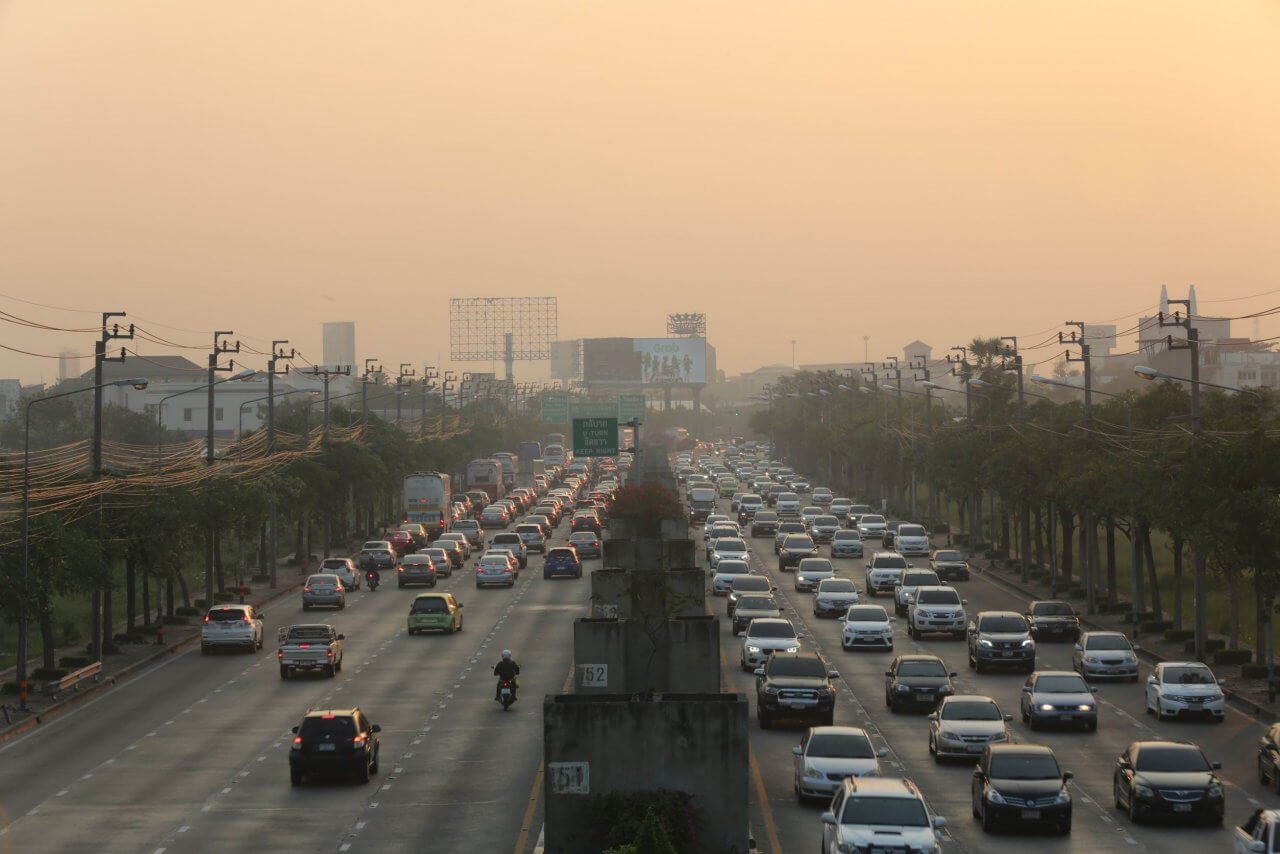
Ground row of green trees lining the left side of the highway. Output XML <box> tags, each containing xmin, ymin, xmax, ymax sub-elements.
<box><xmin>0</xmin><ymin>399</ymin><xmax>541</xmax><ymax>668</ymax></box>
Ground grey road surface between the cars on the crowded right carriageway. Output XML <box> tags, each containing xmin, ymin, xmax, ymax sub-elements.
<box><xmin>694</xmin><ymin>483</ymin><xmax>1280</xmax><ymax>851</ymax></box>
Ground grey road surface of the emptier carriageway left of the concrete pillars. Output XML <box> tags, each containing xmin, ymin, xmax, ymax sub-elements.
<box><xmin>0</xmin><ymin>524</ymin><xmax>588</xmax><ymax>853</ymax></box>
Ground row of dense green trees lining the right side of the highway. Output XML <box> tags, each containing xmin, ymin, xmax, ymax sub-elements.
<box><xmin>753</xmin><ymin>339</ymin><xmax>1280</xmax><ymax>661</ymax></box>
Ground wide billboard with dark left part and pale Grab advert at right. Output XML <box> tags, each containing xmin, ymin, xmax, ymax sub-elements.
<box><xmin>582</xmin><ymin>338</ymin><xmax>707</xmax><ymax>385</ymax></box>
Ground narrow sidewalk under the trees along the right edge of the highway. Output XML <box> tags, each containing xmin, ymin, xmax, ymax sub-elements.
<box><xmin>969</xmin><ymin>554</ymin><xmax>1280</xmax><ymax>722</ymax></box>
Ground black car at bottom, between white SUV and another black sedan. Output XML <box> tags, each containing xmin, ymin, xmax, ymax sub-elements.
<box><xmin>970</xmin><ymin>744</ymin><xmax>1071</xmax><ymax>836</ymax></box>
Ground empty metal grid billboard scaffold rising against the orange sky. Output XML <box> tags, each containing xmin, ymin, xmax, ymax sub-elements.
<box><xmin>449</xmin><ymin>297</ymin><xmax>559</xmax><ymax>380</ymax></box>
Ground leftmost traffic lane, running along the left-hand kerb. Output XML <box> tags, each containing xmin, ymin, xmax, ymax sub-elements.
<box><xmin>0</xmin><ymin>573</ymin><xmax>386</xmax><ymax>828</ymax></box>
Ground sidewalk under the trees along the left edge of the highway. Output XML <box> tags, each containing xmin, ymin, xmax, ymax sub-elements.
<box><xmin>0</xmin><ymin>562</ymin><xmax>306</xmax><ymax>744</ymax></box>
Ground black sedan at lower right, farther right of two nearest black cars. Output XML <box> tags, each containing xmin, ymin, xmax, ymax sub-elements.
<box><xmin>1112</xmin><ymin>741</ymin><xmax>1226</xmax><ymax>825</ymax></box>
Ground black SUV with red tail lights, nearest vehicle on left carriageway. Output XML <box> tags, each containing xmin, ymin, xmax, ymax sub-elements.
<box><xmin>289</xmin><ymin>708</ymin><xmax>383</xmax><ymax>786</ymax></box>
